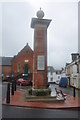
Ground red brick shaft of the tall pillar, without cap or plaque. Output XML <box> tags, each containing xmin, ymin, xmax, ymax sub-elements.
<box><xmin>33</xmin><ymin>26</ymin><xmax>47</xmax><ymax>88</ymax></box>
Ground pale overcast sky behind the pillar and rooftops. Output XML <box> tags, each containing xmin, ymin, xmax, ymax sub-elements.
<box><xmin>0</xmin><ymin>0</ymin><xmax>78</xmax><ymax>69</ymax></box>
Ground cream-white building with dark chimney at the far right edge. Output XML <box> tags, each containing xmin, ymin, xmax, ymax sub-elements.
<box><xmin>66</xmin><ymin>53</ymin><xmax>80</xmax><ymax>88</ymax></box>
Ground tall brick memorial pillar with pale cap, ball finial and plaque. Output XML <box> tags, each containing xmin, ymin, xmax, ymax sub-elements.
<box><xmin>31</xmin><ymin>8</ymin><xmax>51</xmax><ymax>89</ymax></box>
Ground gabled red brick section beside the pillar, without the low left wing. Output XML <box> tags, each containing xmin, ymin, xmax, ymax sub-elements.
<box><xmin>12</xmin><ymin>44</ymin><xmax>33</xmax><ymax>76</ymax></box>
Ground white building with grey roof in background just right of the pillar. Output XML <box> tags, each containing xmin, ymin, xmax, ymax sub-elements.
<box><xmin>47</xmin><ymin>66</ymin><xmax>61</xmax><ymax>84</ymax></box>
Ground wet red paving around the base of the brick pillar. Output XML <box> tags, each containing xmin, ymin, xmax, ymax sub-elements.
<box><xmin>2</xmin><ymin>90</ymin><xmax>80</xmax><ymax>109</ymax></box>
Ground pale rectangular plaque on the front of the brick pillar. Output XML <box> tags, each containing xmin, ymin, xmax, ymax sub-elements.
<box><xmin>37</xmin><ymin>55</ymin><xmax>45</xmax><ymax>70</ymax></box>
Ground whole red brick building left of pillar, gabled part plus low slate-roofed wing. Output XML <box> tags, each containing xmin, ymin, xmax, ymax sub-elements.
<box><xmin>0</xmin><ymin>44</ymin><xmax>33</xmax><ymax>77</ymax></box>
